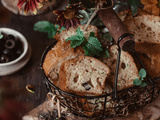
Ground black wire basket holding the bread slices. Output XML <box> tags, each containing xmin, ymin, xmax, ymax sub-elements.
<box><xmin>41</xmin><ymin>34</ymin><xmax>160</xmax><ymax>119</ymax></box>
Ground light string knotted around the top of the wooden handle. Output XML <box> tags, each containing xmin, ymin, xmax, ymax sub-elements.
<box><xmin>84</xmin><ymin>0</ymin><xmax>113</xmax><ymax>31</ymax></box>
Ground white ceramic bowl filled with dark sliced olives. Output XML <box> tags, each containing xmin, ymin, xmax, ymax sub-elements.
<box><xmin>0</xmin><ymin>28</ymin><xmax>31</xmax><ymax>76</ymax></box>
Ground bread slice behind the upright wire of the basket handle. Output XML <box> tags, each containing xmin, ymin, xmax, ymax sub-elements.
<box><xmin>101</xmin><ymin>45</ymin><xmax>138</xmax><ymax>90</ymax></box>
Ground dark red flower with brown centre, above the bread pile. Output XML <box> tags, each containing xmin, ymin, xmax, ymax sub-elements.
<box><xmin>53</xmin><ymin>3</ymin><xmax>83</xmax><ymax>29</ymax></box>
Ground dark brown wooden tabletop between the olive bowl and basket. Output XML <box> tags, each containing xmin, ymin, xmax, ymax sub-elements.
<box><xmin>0</xmin><ymin>0</ymin><xmax>66</xmax><ymax>116</ymax></box>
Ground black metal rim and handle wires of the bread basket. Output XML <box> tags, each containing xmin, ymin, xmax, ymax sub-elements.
<box><xmin>40</xmin><ymin>33</ymin><xmax>160</xmax><ymax>117</ymax></box>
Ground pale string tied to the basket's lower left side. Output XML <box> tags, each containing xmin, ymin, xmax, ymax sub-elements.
<box><xmin>47</xmin><ymin>92</ymin><xmax>61</xmax><ymax>118</ymax></box>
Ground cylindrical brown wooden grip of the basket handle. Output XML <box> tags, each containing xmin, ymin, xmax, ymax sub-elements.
<box><xmin>98</xmin><ymin>8</ymin><xmax>135</xmax><ymax>51</ymax></box>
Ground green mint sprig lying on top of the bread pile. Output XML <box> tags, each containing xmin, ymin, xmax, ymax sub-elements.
<box><xmin>65</xmin><ymin>27</ymin><xmax>103</xmax><ymax>56</ymax></box>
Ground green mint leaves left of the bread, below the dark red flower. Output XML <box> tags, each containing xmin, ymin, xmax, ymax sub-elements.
<box><xmin>34</xmin><ymin>21</ymin><xmax>65</xmax><ymax>39</ymax></box>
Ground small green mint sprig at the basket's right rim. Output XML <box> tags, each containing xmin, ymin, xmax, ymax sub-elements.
<box><xmin>133</xmin><ymin>68</ymin><xmax>147</xmax><ymax>87</ymax></box>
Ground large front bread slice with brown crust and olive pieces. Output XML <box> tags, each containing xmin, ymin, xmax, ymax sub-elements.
<box><xmin>59</xmin><ymin>55</ymin><xmax>110</xmax><ymax>95</ymax></box>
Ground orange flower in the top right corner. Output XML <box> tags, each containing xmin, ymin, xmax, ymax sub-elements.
<box><xmin>141</xmin><ymin>0</ymin><xmax>160</xmax><ymax>16</ymax></box>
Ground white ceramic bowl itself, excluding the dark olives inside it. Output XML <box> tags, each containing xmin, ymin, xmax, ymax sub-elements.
<box><xmin>0</xmin><ymin>28</ymin><xmax>31</xmax><ymax>76</ymax></box>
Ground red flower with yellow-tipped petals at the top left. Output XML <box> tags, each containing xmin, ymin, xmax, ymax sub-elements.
<box><xmin>17</xmin><ymin>0</ymin><xmax>44</xmax><ymax>14</ymax></box>
